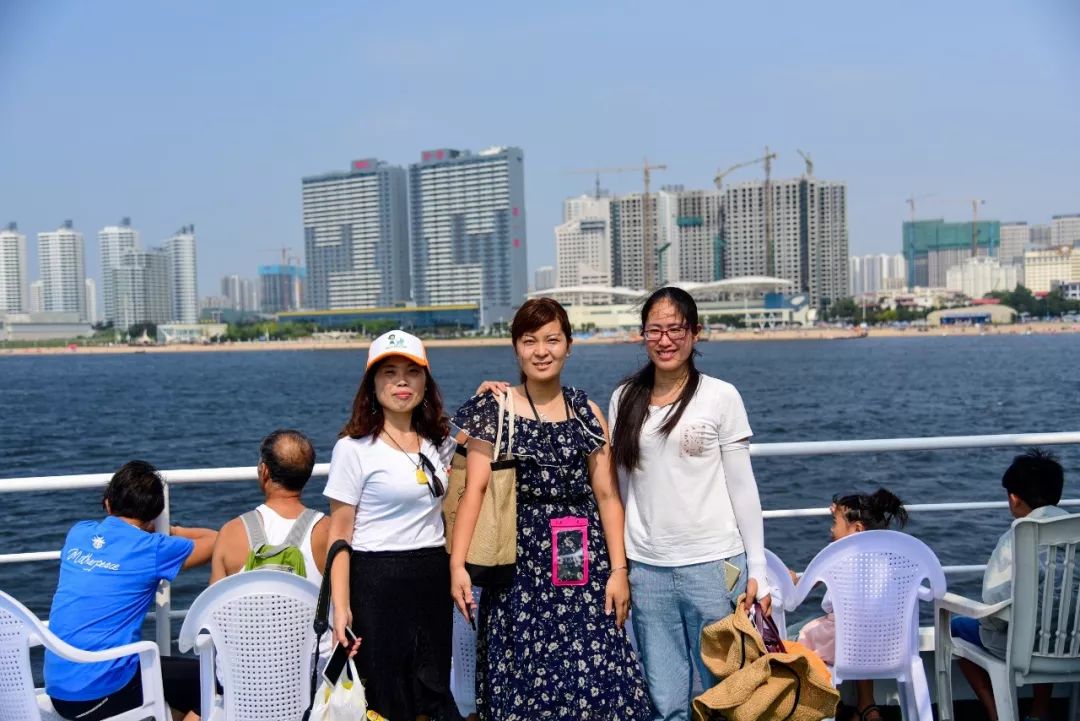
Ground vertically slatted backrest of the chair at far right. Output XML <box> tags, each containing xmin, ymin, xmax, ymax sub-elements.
<box><xmin>1008</xmin><ymin>515</ymin><xmax>1080</xmax><ymax>674</ymax></box>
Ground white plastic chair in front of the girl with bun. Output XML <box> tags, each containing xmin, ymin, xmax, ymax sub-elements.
<box><xmin>784</xmin><ymin>531</ymin><xmax>945</xmax><ymax>721</ymax></box>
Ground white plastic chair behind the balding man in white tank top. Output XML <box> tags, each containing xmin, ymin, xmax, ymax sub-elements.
<box><xmin>178</xmin><ymin>571</ymin><xmax>319</xmax><ymax>721</ymax></box>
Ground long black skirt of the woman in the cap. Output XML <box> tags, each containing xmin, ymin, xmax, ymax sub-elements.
<box><xmin>349</xmin><ymin>546</ymin><xmax>454</xmax><ymax>721</ymax></box>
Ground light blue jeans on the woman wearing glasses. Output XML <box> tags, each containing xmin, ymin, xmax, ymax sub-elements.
<box><xmin>630</xmin><ymin>554</ymin><xmax>746</xmax><ymax>721</ymax></box>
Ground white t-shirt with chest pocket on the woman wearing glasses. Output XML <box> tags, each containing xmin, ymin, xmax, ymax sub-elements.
<box><xmin>608</xmin><ymin>375</ymin><xmax>760</xmax><ymax>567</ymax></box>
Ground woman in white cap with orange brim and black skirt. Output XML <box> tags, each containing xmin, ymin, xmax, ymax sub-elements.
<box><xmin>324</xmin><ymin>330</ymin><xmax>456</xmax><ymax>721</ymax></box>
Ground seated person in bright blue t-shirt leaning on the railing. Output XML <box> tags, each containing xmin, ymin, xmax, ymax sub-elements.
<box><xmin>44</xmin><ymin>461</ymin><xmax>217</xmax><ymax>721</ymax></box>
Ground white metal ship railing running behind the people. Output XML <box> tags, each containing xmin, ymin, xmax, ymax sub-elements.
<box><xmin>0</xmin><ymin>432</ymin><xmax>1080</xmax><ymax>654</ymax></box>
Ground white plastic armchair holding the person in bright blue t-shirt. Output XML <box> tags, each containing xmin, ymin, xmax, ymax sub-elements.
<box><xmin>0</xmin><ymin>590</ymin><xmax>172</xmax><ymax>721</ymax></box>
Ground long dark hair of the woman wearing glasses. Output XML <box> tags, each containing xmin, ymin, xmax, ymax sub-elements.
<box><xmin>611</xmin><ymin>287</ymin><xmax>701</xmax><ymax>471</ymax></box>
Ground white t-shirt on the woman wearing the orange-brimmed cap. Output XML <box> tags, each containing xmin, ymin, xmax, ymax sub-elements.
<box><xmin>323</xmin><ymin>436</ymin><xmax>456</xmax><ymax>550</ymax></box>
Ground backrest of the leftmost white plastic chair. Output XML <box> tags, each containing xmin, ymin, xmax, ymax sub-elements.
<box><xmin>0</xmin><ymin>591</ymin><xmax>49</xmax><ymax>721</ymax></box>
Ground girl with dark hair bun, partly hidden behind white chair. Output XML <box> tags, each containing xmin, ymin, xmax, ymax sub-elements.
<box><xmin>792</xmin><ymin>488</ymin><xmax>907</xmax><ymax>721</ymax></box>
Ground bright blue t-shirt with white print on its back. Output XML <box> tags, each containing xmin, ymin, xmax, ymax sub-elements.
<box><xmin>44</xmin><ymin>516</ymin><xmax>194</xmax><ymax>700</ymax></box>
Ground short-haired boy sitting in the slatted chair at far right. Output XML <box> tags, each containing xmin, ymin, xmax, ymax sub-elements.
<box><xmin>951</xmin><ymin>448</ymin><xmax>1068</xmax><ymax>721</ymax></box>
